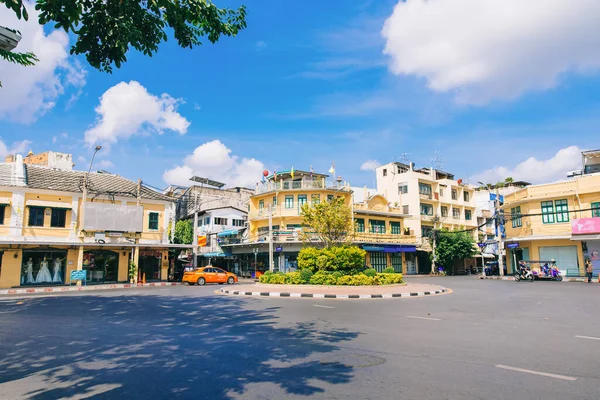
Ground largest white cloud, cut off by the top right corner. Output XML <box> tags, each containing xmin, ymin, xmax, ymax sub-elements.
<box><xmin>382</xmin><ymin>0</ymin><xmax>600</xmax><ymax>105</ymax></box>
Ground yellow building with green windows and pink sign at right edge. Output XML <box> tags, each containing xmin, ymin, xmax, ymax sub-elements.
<box><xmin>503</xmin><ymin>151</ymin><xmax>600</xmax><ymax>274</ymax></box>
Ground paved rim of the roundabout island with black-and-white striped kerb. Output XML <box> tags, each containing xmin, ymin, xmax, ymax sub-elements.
<box><xmin>219</xmin><ymin>283</ymin><xmax>450</xmax><ymax>299</ymax></box>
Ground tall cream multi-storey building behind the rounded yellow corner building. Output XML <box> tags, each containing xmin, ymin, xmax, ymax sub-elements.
<box><xmin>376</xmin><ymin>162</ymin><xmax>477</xmax><ymax>273</ymax></box>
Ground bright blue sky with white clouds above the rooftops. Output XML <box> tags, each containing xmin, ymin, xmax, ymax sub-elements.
<box><xmin>0</xmin><ymin>0</ymin><xmax>600</xmax><ymax>187</ymax></box>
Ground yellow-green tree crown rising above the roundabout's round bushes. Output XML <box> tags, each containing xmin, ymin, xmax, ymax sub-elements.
<box><xmin>302</xmin><ymin>198</ymin><xmax>353</xmax><ymax>247</ymax></box>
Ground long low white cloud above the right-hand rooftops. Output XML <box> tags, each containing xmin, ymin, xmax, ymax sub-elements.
<box><xmin>470</xmin><ymin>146</ymin><xmax>581</xmax><ymax>184</ymax></box>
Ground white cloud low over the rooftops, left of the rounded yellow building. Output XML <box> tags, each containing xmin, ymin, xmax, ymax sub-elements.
<box><xmin>163</xmin><ymin>140</ymin><xmax>265</xmax><ymax>187</ymax></box>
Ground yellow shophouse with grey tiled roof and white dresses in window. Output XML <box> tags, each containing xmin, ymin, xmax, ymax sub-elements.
<box><xmin>0</xmin><ymin>152</ymin><xmax>188</xmax><ymax>288</ymax></box>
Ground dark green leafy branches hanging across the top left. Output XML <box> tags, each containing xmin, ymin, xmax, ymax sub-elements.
<box><xmin>0</xmin><ymin>0</ymin><xmax>246</xmax><ymax>72</ymax></box>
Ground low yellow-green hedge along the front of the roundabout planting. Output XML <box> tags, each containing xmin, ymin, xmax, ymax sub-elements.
<box><xmin>260</xmin><ymin>270</ymin><xmax>403</xmax><ymax>286</ymax></box>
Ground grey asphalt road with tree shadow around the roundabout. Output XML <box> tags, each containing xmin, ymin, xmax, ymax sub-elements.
<box><xmin>0</xmin><ymin>277</ymin><xmax>600</xmax><ymax>400</ymax></box>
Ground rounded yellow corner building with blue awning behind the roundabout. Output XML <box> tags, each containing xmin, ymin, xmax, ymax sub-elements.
<box><xmin>221</xmin><ymin>171</ymin><xmax>416</xmax><ymax>271</ymax></box>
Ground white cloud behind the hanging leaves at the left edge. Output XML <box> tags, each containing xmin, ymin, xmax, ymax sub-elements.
<box><xmin>0</xmin><ymin>3</ymin><xmax>86</xmax><ymax>123</ymax></box>
